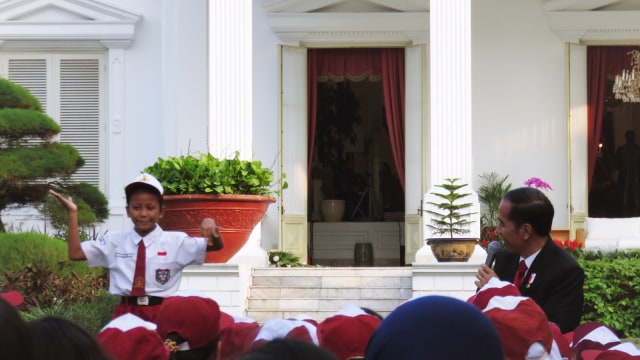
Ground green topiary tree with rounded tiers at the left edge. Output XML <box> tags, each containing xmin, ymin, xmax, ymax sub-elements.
<box><xmin>0</xmin><ymin>78</ymin><xmax>108</xmax><ymax>232</ymax></box>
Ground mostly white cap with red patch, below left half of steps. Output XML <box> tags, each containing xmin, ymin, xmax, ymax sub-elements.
<box><xmin>253</xmin><ymin>317</ymin><xmax>319</xmax><ymax>346</ymax></box>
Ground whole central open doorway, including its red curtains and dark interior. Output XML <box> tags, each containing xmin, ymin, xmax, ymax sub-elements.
<box><xmin>307</xmin><ymin>48</ymin><xmax>405</xmax><ymax>266</ymax></box>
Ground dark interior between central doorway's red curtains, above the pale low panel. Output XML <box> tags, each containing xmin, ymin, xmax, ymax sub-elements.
<box><xmin>308</xmin><ymin>79</ymin><xmax>404</xmax><ymax>221</ymax></box>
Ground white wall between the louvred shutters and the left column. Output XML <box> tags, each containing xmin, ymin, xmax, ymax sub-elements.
<box><xmin>106</xmin><ymin>0</ymin><xmax>208</xmax><ymax>230</ymax></box>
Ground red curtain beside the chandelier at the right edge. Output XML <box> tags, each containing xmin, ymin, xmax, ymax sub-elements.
<box><xmin>587</xmin><ymin>46</ymin><xmax>640</xmax><ymax>190</ymax></box>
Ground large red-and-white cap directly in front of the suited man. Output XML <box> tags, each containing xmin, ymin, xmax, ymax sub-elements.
<box><xmin>472</xmin><ymin>278</ymin><xmax>559</xmax><ymax>359</ymax></box>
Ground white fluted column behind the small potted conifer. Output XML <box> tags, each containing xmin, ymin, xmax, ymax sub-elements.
<box><xmin>416</xmin><ymin>0</ymin><xmax>480</xmax><ymax>263</ymax></box>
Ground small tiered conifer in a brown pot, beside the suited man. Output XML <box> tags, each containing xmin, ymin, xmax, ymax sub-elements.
<box><xmin>426</xmin><ymin>178</ymin><xmax>478</xmax><ymax>262</ymax></box>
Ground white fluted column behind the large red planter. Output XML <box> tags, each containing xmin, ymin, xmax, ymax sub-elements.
<box><xmin>209</xmin><ymin>0</ymin><xmax>268</xmax><ymax>276</ymax></box>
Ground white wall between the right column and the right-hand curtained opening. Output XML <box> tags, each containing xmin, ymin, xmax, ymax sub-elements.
<box><xmin>472</xmin><ymin>0</ymin><xmax>569</xmax><ymax>228</ymax></box>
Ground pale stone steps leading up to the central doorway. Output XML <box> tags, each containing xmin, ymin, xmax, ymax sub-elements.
<box><xmin>247</xmin><ymin>267</ymin><xmax>412</xmax><ymax>322</ymax></box>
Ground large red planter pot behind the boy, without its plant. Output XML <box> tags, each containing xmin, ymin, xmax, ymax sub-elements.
<box><xmin>160</xmin><ymin>194</ymin><xmax>276</xmax><ymax>263</ymax></box>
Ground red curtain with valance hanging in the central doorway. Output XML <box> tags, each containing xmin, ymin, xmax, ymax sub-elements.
<box><xmin>307</xmin><ymin>48</ymin><xmax>404</xmax><ymax>189</ymax></box>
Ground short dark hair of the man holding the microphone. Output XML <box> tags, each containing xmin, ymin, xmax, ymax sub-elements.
<box><xmin>502</xmin><ymin>187</ymin><xmax>553</xmax><ymax>236</ymax></box>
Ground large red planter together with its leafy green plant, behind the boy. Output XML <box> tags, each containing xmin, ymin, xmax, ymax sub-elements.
<box><xmin>143</xmin><ymin>152</ymin><xmax>286</xmax><ymax>263</ymax></box>
